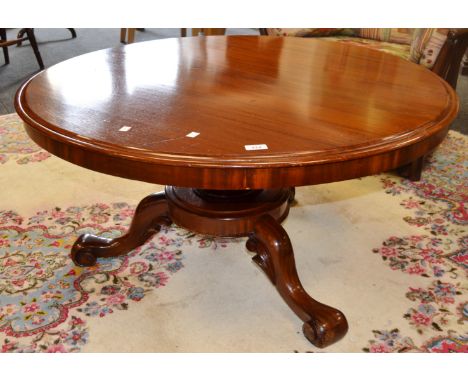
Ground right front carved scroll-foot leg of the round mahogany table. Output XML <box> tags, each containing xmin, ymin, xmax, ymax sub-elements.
<box><xmin>247</xmin><ymin>215</ymin><xmax>348</xmax><ymax>348</ymax></box>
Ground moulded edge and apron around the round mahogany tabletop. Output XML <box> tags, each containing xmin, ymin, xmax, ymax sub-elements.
<box><xmin>15</xmin><ymin>36</ymin><xmax>459</xmax><ymax>189</ymax></box>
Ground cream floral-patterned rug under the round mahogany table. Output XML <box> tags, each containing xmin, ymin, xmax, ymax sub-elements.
<box><xmin>0</xmin><ymin>114</ymin><xmax>468</xmax><ymax>352</ymax></box>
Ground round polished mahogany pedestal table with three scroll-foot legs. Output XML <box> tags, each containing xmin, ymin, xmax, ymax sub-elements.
<box><xmin>16</xmin><ymin>36</ymin><xmax>458</xmax><ymax>347</ymax></box>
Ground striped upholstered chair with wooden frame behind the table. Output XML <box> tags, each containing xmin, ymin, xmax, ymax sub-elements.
<box><xmin>260</xmin><ymin>28</ymin><xmax>468</xmax><ymax>88</ymax></box>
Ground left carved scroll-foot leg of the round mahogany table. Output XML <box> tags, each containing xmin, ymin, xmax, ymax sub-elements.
<box><xmin>71</xmin><ymin>192</ymin><xmax>172</xmax><ymax>266</ymax></box>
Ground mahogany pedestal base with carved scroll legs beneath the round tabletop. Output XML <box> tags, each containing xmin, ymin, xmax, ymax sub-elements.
<box><xmin>71</xmin><ymin>186</ymin><xmax>348</xmax><ymax>348</ymax></box>
